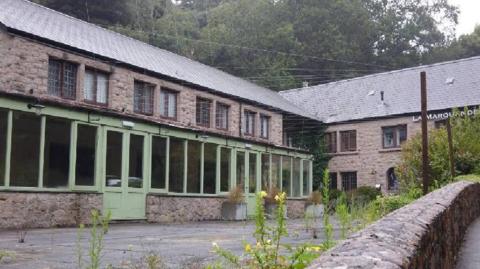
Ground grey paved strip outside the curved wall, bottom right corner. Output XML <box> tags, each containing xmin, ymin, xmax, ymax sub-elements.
<box><xmin>457</xmin><ymin>218</ymin><xmax>480</xmax><ymax>269</ymax></box>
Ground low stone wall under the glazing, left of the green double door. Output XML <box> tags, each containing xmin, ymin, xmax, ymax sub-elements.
<box><xmin>0</xmin><ymin>192</ymin><xmax>103</xmax><ymax>229</ymax></box>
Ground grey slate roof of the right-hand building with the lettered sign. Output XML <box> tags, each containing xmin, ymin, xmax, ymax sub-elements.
<box><xmin>280</xmin><ymin>57</ymin><xmax>480</xmax><ymax>123</ymax></box>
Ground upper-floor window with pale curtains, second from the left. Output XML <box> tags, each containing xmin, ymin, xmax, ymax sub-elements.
<box><xmin>83</xmin><ymin>69</ymin><xmax>108</xmax><ymax>105</ymax></box>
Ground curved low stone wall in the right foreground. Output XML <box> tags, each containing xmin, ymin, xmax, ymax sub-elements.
<box><xmin>309</xmin><ymin>181</ymin><xmax>480</xmax><ymax>269</ymax></box>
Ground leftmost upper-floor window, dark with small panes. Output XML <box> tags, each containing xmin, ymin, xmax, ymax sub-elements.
<box><xmin>48</xmin><ymin>59</ymin><xmax>77</xmax><ymax>99</ymax></box>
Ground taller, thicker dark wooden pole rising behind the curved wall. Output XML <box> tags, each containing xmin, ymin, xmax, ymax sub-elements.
<box><xmin>420</xmin><ymin>72</ymin><xmax>430</xmax><ymax>195</ymax></box>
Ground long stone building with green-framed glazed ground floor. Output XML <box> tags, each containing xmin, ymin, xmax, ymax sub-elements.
<box><xmin>0</xmin><ymin>0</ymin><xmax>320</xmax><ymax>228</ymax></box>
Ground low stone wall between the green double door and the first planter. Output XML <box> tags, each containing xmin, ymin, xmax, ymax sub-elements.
<box><xmin>146</xmin><ymin>194</ymin><xmax>225</xmax><ymax>223</ymax></box>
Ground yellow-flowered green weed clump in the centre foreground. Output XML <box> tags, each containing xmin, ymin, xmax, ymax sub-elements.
<box><xmin>212</xmin><ymin>192</ymin><xmax>325</xmax><ymax>269</ymax></box>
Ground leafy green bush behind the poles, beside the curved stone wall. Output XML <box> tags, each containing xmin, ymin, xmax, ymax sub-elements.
<box><xmin>396</xmin><ymin>107</ymin><xmax>480</xmax><ymax>190</ymax></box>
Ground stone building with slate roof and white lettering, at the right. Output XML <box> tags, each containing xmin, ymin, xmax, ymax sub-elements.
<box><xmin>281</xmin><ymin>57</ymin><xmax>480</xmax><ymax>191</ymax></box>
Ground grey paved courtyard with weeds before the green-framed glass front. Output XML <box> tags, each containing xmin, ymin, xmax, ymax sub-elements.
<box><xmin>0</xmin><ymin>220</ymin><xmax>338</xmax><ymax>269</ymax></box>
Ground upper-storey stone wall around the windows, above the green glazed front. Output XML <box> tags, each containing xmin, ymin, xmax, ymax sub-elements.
<box><xmin>0</xmin><ymin>29</ymin><xmax>283</xmax><ymax>145</ymax></box>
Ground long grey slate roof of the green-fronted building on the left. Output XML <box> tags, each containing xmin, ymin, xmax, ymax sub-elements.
<box><xmin>0</xmin><ymin>0</ymin><xmax>314</xmax><ymax>119</ymax></box>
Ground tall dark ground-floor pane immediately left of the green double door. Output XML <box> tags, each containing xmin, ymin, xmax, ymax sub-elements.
<box><xmin>75</xmin><ymin>124</ymin><xmax>97</xmax><ymax>186</ymax></box>
